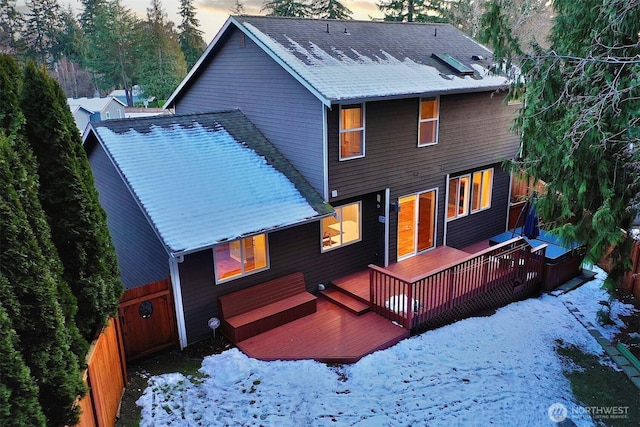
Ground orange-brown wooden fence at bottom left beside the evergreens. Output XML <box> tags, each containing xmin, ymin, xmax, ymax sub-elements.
<box><xmin>78</xmin><ymin>318</ymin><xmax>127</xmax><ymax>427</ymax></box>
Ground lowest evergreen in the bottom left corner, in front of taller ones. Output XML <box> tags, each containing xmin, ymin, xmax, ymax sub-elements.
<box><xmin>0</xmin><ymin>272</ymin><xmax>45</xmax><ymax>427</ymax></box>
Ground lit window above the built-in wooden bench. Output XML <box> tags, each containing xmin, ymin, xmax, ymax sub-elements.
<box><xmin>213</xmin><ymin>234</ymin><xmax>269</xmax><ymax>283</ymax></box>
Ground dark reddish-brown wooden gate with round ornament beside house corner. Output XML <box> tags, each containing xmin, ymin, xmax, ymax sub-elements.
<box><xmin>119</xmin><ymin>278</ymin><xmax>178</xmax><ymax>360</ymax></box>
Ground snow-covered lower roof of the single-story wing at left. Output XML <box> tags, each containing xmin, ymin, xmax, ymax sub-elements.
<box><xmin>90</xmin><ymin>110</ymin><xmax>333</xmax><ymax>254</ymax></box>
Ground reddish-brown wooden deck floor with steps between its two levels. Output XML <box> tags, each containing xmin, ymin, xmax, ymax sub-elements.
<box><xmin>237</xmin><ymin>246</ymin><xmax>476</xmax><ymax>363</ymax></box>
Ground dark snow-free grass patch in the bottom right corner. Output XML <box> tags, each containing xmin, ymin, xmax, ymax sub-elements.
<box><xmin>557</xmin><ymin>346</ymin><xmax>640</xmax><ymax>427</ymax></box>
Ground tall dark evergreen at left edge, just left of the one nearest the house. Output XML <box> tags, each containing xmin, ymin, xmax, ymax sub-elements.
<box><xmin>0</xmin><ymin>118</ymin><xmax>85</xmax><ymax>426</ymax></box>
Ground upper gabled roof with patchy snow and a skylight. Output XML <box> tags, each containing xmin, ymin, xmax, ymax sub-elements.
<box><xmin>166</xmin><ymin>16</ymin><xmax>508</xmax><ymax>107</ymax></box>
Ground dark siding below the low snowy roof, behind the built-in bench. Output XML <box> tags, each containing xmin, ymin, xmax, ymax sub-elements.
<box><xmin>179</xmin><ymin>194</ymin><xmax>379</xmax><ymax>344</ymax></box>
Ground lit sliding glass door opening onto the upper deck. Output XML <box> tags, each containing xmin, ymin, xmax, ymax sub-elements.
<box><xmin>398</xmin><ymin>190</ymin><xmax>437</xmax><ymax>260</ymax></box>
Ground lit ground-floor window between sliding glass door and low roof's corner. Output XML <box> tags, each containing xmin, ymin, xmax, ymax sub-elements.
<box><xmin>322</xmin><ymin>202</ymin><xmax>362</xmax><ymax>252</ymax></box>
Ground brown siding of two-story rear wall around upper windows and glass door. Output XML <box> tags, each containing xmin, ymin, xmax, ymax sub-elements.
<box><xmin>328</xmin><ymin>93</ymin><xmax>518</xmax><ymax>262</ymax></box>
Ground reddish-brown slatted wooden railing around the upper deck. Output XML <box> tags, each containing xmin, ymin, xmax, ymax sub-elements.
<box><xmin>369</xmin><ymin>241</ymin><xmax>546</xmax><ymax>329</ymax></box>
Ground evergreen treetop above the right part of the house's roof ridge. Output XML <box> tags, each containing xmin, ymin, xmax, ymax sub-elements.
<box><xmin>376</xmin><ymin>0</ymin><xmax>447</xmax><ymax>22</ymax></box>
